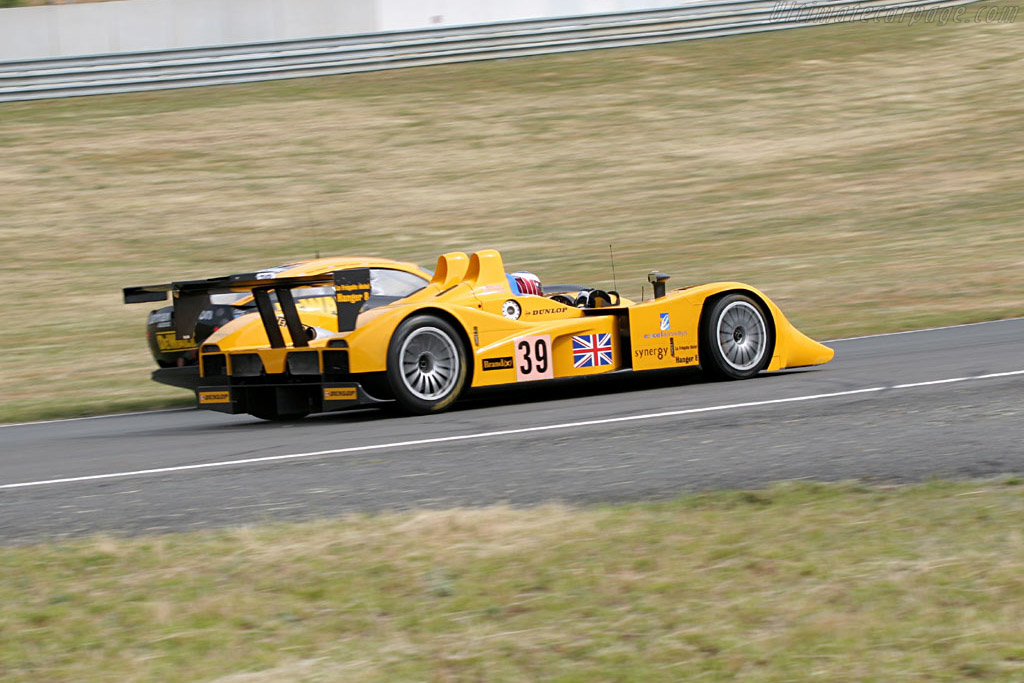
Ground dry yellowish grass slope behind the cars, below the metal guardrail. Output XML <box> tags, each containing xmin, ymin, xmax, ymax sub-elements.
<box><xmin>0</xmin><ymin>6</ymin><xmax>1024</xmax><ymax>421</ymax></box>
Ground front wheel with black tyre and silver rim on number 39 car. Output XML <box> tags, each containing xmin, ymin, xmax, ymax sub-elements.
<box><xmin>700</xmin><ymin>294</ymin><xmax>774</xmax><ymax>380</ymax></box>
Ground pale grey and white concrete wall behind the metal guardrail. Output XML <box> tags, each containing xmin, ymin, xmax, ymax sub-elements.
<box><xmin>0</xmin><ymin>0</ymin><xmax>681</xmax><ymax>61</ymax></box>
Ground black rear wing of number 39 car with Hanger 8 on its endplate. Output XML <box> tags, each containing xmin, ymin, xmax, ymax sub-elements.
<box><xmin>124</xmin><ymin>268</ymin><xmax>370</xmax><ymax>348</ymax></box>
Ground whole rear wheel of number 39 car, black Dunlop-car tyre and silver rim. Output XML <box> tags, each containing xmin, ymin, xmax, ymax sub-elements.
<box><xmin>387</xmin><ymin>314</ymin><xmax>469</xmax><ymax>415</ymax></box>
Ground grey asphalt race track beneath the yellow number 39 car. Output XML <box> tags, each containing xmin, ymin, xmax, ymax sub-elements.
<box><xmin>0</xmin><ymin>318</ymin><xmax>1024</xmax><ymax>543</ymax></box>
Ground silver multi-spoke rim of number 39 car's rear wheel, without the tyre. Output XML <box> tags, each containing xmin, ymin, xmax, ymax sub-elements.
<box><xmin>398</xmin><ymin>328</ymin><xmax>460</xmax><ymax>400</ymax></box>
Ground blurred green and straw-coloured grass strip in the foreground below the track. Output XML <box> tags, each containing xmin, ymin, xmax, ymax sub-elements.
<box><xmin>0</xmin><ymin>479</ymin><xmax>1024</xmax><ymax>683</ymax></box>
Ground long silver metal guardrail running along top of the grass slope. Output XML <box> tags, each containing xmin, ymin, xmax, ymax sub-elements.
<box><xmin>0</xmin><ymin>0</ymin><xmax>975</xmax><ymax>102</ymax></box>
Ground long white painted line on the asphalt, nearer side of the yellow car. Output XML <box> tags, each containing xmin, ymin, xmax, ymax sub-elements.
<box><xmin>0</xmin><ymin>370</ymin><xmax>1024</xmax><ymax>490</ymax></box>
